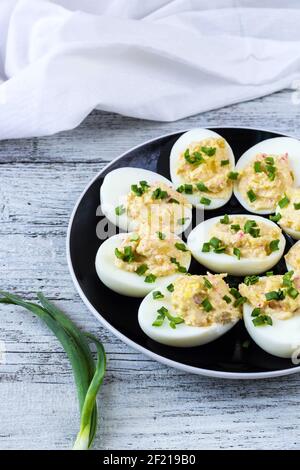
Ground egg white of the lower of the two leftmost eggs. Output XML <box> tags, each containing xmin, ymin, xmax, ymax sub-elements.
<box><xmin>95</xmin><ymin>233</ymin><xmax>191</xmax><ymax>297</ymax></box>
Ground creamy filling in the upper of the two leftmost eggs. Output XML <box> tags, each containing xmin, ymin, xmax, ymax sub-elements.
<box><xmin>124</xmin><ymin>181</ymin><xmax>191</xmax><ymax>232</ymax></box>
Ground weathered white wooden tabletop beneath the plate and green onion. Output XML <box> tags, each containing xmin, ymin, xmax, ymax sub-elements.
<box><xmin>0</xmin><ymin>91</ymin><xmax>300</xmax><ymax>449</ymax></box>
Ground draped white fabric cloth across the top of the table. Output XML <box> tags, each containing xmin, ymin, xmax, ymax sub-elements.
<box><xmin>0</xmin><ymin>0</ymin><xmax>300</xmax><ymax>139</ymax></box>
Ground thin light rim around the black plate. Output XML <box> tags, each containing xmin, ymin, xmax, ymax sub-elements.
<box><xmin>66</xmin><ymin>125</ymin><xmax>300</xmax><ymax>380</ymax></box>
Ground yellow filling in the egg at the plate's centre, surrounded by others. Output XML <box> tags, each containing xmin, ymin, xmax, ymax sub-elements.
<box><xmin>210</xmin><ymin>216</ymin><xmax>281</xmax><ymax>258</ymax></box>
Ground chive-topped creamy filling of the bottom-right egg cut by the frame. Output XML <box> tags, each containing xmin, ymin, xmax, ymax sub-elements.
<box><xmin>239</xmin><ymin>271</ymin><xmax>300</xmax><ymax>326</ymax></box>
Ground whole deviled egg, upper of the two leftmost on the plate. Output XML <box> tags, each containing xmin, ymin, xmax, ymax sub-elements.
<box><xmin>100</xmin><ymin>167</ymin><xmax>192</xmax><ymax>233</ymax></box>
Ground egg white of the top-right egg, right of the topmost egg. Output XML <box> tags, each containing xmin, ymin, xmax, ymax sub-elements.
<box><xmin>234</xmin><ymin>137</ymin><xmax>300</xmax><ymax>214</ymax></box>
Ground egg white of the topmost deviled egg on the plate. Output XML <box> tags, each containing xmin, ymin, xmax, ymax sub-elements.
<box><xmin>170</xmin><ymin>128</ymin><xmax>235</xmax><ymax>210</ymax></box>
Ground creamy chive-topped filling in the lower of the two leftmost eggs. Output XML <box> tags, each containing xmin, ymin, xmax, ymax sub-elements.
<box><xmin>115</xmin><ymin>230</ymin><xmax>190</xmax><ymax>282</ymax></box>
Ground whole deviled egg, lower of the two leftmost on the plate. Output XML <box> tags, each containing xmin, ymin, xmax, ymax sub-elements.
<box><xmin>96</xmin><ymin>226</ymin><xmax>191</xmax><ymax>297</ymax></box>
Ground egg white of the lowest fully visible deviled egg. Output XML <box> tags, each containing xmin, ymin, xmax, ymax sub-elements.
<box><xmin>138</xmin><ymin>284</ymin><xmax>238</xmax><ymax>348</ymax></box>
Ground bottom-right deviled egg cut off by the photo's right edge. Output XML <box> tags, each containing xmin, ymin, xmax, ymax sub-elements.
<box><xmin>239</xmin><ymin>271</ymin><xmax>300</xmax><ymax>358</ymax></box>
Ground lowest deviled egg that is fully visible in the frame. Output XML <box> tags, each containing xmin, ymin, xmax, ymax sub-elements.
<box><xmin>138</xmin><ymin>273</ymin><xmax>242</xmax><ymax>347</ymax></box>
